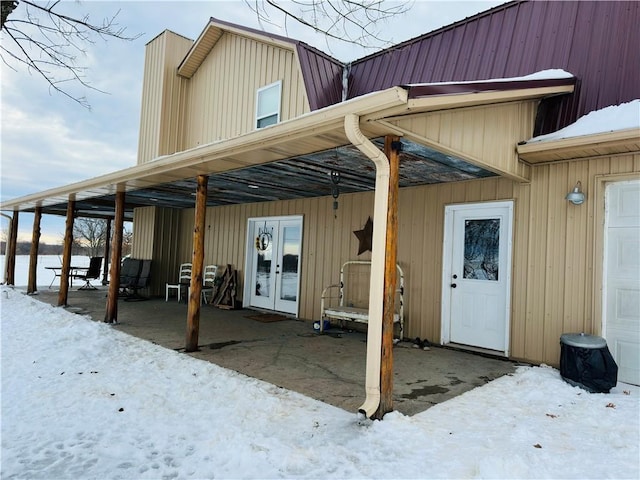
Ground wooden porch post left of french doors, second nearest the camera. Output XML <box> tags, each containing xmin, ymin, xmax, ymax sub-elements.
<box><xmin>185</xmin><ymin>175</ymin><xmax>209</xmax><ymax>352</ymax></box>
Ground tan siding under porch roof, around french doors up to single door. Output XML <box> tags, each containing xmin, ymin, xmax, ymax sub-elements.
<box><xmin>168</xmin><ymin>177</ymin><xmax>515</xmax><ymax>340</ymax></box>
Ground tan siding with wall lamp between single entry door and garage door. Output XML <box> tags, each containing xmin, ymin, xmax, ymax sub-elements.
<box><xmin>511</xmin><ymin>153</ymin><xmax>640</xmax><ymax>365</ymax></box>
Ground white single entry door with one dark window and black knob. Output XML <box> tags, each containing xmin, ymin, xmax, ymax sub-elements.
<box><xmin>442</xmin><ymin>202</ymin><xmax>513</xmax><ymax>356</ymax></box>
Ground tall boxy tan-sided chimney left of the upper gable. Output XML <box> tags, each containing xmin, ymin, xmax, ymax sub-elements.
<box><xmin>138</xmin><ymin>30</ymin><xmax>193</xmax><ymax>164</ymax></box>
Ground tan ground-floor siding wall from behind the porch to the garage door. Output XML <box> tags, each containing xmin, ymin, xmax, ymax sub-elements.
<box><xmin>156</xmin><ymin>154</ymin><xmax>640</xmax><ymax>365</ymax></box>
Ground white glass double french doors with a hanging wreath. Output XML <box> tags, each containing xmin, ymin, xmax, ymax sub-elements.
<box><xmin>244</xmin><ymin>216</ymin><xmax>302</xmax><ymax>315</ymax></box>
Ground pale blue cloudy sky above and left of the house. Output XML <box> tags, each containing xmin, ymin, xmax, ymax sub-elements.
<box><xmin>0</xmin><ymin>0</ymin><xmax>505</xmax><ymax>243</ymax></box>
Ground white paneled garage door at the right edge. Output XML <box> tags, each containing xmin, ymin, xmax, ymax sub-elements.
<box><xmin>603</xmin><ymin>181</ymin><xmax>640</xmax><ymax>385</ymax></box>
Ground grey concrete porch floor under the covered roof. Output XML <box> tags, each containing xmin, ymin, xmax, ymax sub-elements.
<box><xmin>36</xmin><ymin>287</ymin><xmax>517</xmax><ymax>415</ymax></box>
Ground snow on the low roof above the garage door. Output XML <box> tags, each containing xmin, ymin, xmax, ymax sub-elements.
<box><xmin>527</xmin><ymin>99</ymin><xmax>640</xmax><ymax>143</ymax></box>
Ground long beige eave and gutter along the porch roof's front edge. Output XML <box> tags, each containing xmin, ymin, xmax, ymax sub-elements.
<box><xmin>0</xmin><ymin>87</ymin><xmax>407</xmax><ymax>211</ymax></box>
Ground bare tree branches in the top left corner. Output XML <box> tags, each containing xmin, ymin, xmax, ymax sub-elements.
<box><xmin>0</xmin><ymin>0</ymin><xmax>141</xmax><ymax>108</ymax></box>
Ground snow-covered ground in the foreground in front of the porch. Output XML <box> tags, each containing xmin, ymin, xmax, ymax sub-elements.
<box><xmin>0</xmin><ymin>287</ymin><xmax>640</xmax><ymax>480</ymax></box>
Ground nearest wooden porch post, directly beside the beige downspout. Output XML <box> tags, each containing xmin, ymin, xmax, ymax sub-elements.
<box><xmin>373</xmin><ymin>135</ymin><xmax>400</xmax><ymax>420</ymax></box>
